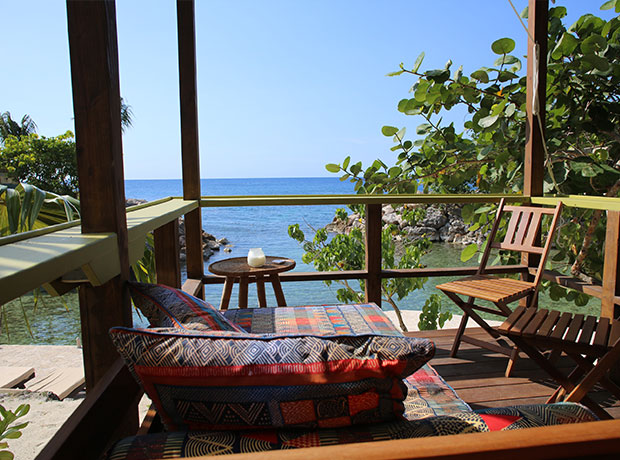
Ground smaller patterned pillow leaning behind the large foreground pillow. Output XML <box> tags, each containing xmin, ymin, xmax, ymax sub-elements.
<box><xmin>128</xmin><ymin>282</ymin><xmax>244</xmax><ymax>332</ymax></box>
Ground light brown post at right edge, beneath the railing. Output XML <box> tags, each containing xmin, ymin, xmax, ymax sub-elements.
<box><xmin>601</xmin><ymin>211</ymin><xmax>620</xmax><ymax>319</ymax></box>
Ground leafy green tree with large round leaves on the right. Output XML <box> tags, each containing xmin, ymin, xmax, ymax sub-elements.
<box><xmin>326</xmin><ymin>0</ymin><xmax>620</xmax><ymax>310</ymax></box>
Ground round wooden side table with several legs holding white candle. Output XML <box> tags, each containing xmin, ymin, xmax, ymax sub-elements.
<box><xmin>209</xmin><ymin>256</ymin><xmax>295</xmax><ymax>310</ymax></box>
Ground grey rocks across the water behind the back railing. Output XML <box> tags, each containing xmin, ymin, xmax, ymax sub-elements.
<box><xmin>326</xmin><ymin>204</ymin><xmax>485</xmax><ymax>245</ymax></box>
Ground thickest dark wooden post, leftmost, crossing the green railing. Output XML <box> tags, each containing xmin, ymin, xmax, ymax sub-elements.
<box><xmin>67</xmin><ymin>0</ymin><xmax>137</xmax><ymax>402</ymax></box>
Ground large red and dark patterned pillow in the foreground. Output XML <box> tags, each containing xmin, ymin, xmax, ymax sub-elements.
<box><xmin>110</xmin><ymin>328</ymin><xmax>435</xmax><ymax>430</ymax></box>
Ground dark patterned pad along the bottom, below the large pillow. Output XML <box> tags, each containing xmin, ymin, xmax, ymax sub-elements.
<box><xmin>108</xmin><ymin>403</ymin><xmax>596</xmax><ymax>460</ymax></box>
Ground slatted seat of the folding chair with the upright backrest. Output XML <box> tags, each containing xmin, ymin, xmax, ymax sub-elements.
<box><xmin>437</xmin><ymin>275</ymin><xmax>535</xmax><ymax>303</ymax></box>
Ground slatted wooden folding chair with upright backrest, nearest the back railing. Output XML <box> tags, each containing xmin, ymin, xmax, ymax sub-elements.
<box><xmin>437</xmin><ymin>199</ymin><xmax>562</xmax><ymax>376</ymax></box>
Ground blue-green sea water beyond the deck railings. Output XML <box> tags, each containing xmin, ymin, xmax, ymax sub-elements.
<box><xmin>0</xmin><ymin>177</ymin><xmax>600</xmax><ymax>344</ymax></box>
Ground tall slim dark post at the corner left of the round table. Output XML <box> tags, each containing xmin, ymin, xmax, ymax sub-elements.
<box><xmin>177</xmin><ymin>0</ymin><xmax>204</xmax><ymax>297</ymax></box>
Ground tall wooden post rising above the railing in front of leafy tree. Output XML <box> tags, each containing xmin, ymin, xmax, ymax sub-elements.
<box><xmin>523</xmin><ymin>0</ymin><xmax>549</xmax><ymax>196</ymax></box>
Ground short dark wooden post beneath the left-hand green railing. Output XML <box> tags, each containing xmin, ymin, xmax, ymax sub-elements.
<box><xmin>153</xmin><ymin>219</ymin><xmax>181</xmax><ymax>288</ymax></box>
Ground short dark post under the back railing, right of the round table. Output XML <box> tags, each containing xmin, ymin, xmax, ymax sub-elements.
<box><xmin>366</xmin><ymin>204</ymin><xmax>382</xmax><ymax>306</ymax></box>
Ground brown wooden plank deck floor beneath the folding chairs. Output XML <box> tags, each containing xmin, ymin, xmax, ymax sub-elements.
<box><xmin>406</xmin><ymin>328</ymin><xmax>620</xmax><ymax>418</ymax></box>
